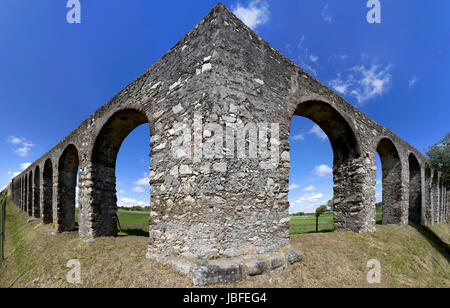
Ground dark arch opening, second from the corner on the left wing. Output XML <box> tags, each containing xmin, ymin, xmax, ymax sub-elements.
<box><xmin>56</xmin><ymin>144</ymin><xmax>79</xmax><ymax>232</ymax></box>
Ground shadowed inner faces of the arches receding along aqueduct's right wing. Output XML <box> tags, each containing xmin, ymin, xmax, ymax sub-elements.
<box><xmin>294</xmin><ymin>101</ymin><xmax>447</xmax><ymax>228</ymax></box>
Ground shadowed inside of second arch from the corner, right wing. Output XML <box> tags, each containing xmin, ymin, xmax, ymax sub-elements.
<box><xmin>376</xmin><ymin>137</ymin><xmax>407</xmax><ymax>225</ymax></box>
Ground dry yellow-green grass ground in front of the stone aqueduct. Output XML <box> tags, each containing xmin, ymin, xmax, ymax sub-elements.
<box><xmin>0</xmin><ymin>199</ymin><xmax>450</xmax><ymax>288</ymax></box>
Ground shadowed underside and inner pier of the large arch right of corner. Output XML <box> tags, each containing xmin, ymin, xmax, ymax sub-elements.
<box><xmin>293</xmin><ymin>100</ymin><xmax>366</xmax><ymax>232</ymax></box>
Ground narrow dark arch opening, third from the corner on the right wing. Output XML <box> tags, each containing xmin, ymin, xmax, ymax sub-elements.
<box><xmin>408</xmin><ymin>153</ymin><xmax>422</xmax><ymax>224</ymax></box>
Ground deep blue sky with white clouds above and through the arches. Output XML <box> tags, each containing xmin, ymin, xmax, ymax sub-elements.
<box><xmin>0</xmin><ymin>0</ymin><xmax>450</xmax><ymax>212</ymax></box>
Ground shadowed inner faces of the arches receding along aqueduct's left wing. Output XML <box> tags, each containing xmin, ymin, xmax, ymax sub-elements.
<box><xmin>12</xmin><ymin>109</ymin><xmax>148</xmax><ymax>236</ymax></box>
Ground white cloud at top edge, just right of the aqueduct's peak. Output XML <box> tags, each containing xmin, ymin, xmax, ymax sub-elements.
<box><xmin>233</xmin><ymin>0</ymin><xmax>270</xmax><ymax>30</ymax></box>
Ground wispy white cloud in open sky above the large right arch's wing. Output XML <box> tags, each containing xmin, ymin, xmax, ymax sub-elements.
<box><xmin>328</xmin><ymin>54</ymin><xmax>392</xmax><ymax>105</ymax></box>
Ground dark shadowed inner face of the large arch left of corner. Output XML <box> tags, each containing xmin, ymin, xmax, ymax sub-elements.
<box><xmin>91</xmin><ymin>109</ymin><xmax>150</xmax><ymax>237</ymax></box>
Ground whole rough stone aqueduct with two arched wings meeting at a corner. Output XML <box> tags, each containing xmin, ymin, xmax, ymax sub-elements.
<box><xmin>6</xmin><ymin>4</ymin><xmax>448</xmax><ymax>284</ymax></box>
